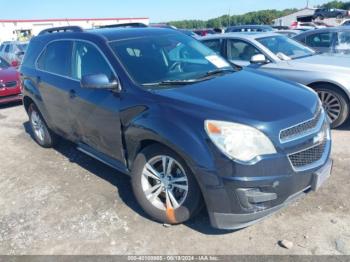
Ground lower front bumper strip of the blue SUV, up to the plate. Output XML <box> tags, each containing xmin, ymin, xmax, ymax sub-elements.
<box><xmin>209</xmin><ymin>159</ymin><xmax>333</xmax><ymax>229</ymax></box>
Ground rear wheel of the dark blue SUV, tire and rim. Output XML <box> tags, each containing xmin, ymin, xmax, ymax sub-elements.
<box><xmin>28</xmin><ymin>103</ymin><xmax>57</xmax><ymax>148</ymax></box>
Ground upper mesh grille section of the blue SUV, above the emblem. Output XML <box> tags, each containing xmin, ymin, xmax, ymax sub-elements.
<box><xmin>280</xmin><ymin>110</ymin><xmax>323</xmax><ymax>143</ymax></box>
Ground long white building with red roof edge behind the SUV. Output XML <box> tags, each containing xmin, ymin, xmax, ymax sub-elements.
<box><xmin>0</xmin><ymin>18</ymin><xmax>149</xmax><ymax>42</ymax></box>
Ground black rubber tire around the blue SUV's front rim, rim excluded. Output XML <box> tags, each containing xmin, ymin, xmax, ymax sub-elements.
<box><xmin>132</xmin><ymin>144</ymin><xmax>203</xmax><ymax>224</ymax></box>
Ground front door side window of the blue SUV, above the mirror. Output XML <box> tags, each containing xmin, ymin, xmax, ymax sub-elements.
<box><xmin>72</xmin><ymin>41</ymin><xmax>114</xmax><ymax>82</ymax></box>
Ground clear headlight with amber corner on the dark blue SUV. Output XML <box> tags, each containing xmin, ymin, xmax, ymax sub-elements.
<box><xmin>204</xmin><ymin>120</ymin><xmax>276</xmax><ymax>162</ymax></box>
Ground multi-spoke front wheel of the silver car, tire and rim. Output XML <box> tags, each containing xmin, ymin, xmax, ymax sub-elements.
<box><xmin>314</xmin><ymin>85</ymin><xmax>349</xmax><ymax>128</ymax></box>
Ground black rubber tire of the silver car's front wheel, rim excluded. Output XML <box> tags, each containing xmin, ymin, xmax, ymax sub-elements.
<box><xmin>314</xmin><ymin>84</ymin><xmax>349</xmax><ymax>128</ymax></box>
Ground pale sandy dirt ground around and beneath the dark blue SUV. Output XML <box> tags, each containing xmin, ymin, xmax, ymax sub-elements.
<box><xmin>0</xmin><ymin>101</ymin><xmax>350</xmax><ymax>255</ymax></box>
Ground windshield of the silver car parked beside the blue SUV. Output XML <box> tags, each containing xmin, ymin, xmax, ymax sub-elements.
<box><xmin>257</xmin><ymin>35</ymin><xmax>315</xmax><ymax>60</ymax></box>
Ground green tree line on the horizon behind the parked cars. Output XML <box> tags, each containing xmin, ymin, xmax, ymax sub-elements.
<box><xmin>168</xmin><ymin>1</ymin><xmax>350</xmax><ymax>29</ymax></box>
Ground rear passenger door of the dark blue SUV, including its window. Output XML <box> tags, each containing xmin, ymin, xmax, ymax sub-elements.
<box><xmin>36</xmin><ymin>40</ymin><xmax>75</xmax><ymax>139</ymax></box>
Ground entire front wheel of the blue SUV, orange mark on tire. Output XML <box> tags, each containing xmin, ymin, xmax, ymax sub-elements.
<box><xmin>131</xmin><ymin>145</ymin><xmax>203</xmax><ymax>224</ymax></box>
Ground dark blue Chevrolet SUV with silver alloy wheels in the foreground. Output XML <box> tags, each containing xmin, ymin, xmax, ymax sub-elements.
<box><xmin>21</xmin><ymin>27</ymin><xmax>332</xmax><ymax>229</ymax></box>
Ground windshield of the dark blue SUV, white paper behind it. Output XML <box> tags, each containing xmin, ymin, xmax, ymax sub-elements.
<box><xmin>110</xmin><ymin>34</ymin><xmax>232</xmax><ymax>85</ymax></box>
